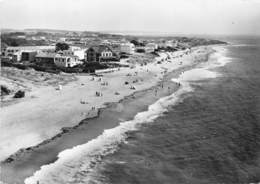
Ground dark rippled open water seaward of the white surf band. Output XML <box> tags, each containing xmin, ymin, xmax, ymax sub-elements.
<box><xmin>89</xmin><ymin>36</ymin><xmax>260</xmax><ymax>184</ymax></box>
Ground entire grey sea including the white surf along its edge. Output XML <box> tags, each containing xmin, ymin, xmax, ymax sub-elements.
<box><xmin>21</xmin><ymin>36</ymin><xmax>260</xmax><ymax>184</ymax></box>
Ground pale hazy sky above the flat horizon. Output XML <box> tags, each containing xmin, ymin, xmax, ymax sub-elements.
<box><xmin>0</xmin><ymin>0</ymin><xmax>260</xmax><ymax>35</ymax></box>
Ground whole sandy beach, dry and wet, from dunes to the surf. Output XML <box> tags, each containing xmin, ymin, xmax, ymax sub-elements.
<box><xmin>1</xmin><ymin>47</ymin><xmax>212</xmax><ymax>183</ymax></box>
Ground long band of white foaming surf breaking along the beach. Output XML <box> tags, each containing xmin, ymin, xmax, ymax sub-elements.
<box><xmin>24</xmin><ymin>45</ymin><xmax>231</xmax><ymax>184</ymax></box>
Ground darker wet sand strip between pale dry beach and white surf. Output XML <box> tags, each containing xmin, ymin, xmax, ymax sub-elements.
<box><xmin>1</xmin><ymin>46</ymin><xmax>213</xmax><ymax>184</ymax></box>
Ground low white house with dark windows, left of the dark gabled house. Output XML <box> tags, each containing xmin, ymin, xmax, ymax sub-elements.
<box><xmin>54</xmin><ymin>54</ymin><xmax>82</xmax><ymax>67</ymax></box>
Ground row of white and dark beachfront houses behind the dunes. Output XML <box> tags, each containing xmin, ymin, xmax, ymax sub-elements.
<box><xmin>2</xmin><ymin>42</ymin><xmax>175</xmax><ymax>67</ymax></box>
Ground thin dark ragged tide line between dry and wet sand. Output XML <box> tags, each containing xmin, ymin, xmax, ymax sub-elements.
<box><xmin>2</xmin><ymin>45</ymin><xmax>215</xmax><ymax>183</ymax></box>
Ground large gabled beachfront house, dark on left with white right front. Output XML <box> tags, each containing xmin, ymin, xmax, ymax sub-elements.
<box><xmin>85</xmin><ymin>45</ymin><xmax>118</xmax><ymax>62</ymax></box>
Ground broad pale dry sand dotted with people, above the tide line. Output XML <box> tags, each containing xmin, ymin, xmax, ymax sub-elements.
<box><xmin>0</xmin><ymin>47</ymin><xmax>212</xmax><ymax>183</ymax></box>
